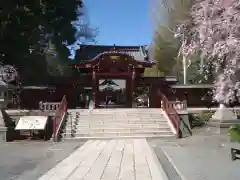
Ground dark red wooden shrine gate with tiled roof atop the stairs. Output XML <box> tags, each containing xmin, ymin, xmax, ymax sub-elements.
<box><xmin>51</xmin><ymin>45</ymin><xmax>176</xmax><ymax>108</ymax></box>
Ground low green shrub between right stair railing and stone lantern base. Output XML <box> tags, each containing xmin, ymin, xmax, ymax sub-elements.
<box><xmin>188</xmin><ymin>113</ymin><xmax>212</xmax><ymax>128</ymax></box>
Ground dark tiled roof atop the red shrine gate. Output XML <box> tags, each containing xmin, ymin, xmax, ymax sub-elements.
<box><xmin>75</xmin><ymin>45</ymin><xmax>154</xmax><ymax>62</ymax></box>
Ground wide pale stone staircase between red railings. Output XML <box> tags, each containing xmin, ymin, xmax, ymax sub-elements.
<box><xmin>62</xmin><ymin>108</ymin><xmax>175</xmax><ymax>140</ymax></box>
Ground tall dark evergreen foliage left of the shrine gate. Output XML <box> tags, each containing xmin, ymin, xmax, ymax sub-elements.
<box><xmin>0</xmin><ymin>0</ymin><xmax>95</xmax><ymax>83</ymax></box>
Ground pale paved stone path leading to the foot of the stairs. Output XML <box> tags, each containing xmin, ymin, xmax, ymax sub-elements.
<box><xmin>39</xmin><ymin>139</ymin><xmax>167</xmax><ymax>180</ymax></box>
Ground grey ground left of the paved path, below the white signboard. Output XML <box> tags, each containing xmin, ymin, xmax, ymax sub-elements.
<box><xmin>0</xmin><ymin>141</ymin><xmax>85</xmax><ymax>180</ymax></box>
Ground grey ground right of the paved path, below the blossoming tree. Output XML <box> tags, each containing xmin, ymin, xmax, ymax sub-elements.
<box><xmin>149</xmin><ymin>126</ymin><xmax>240</xmax><ymax>180</ymax></box>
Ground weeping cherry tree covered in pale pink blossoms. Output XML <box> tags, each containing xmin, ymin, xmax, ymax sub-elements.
<box><xmin>175</xmin><ymin>0</ymin><xmax>240</xmax><ymax>104</ymax></box>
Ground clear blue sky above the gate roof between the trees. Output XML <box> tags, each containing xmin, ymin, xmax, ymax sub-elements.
<box><xmin>84</xmin><ymin>0</ymin><xmax>152</xmax><ymax>45</ymax></box>
